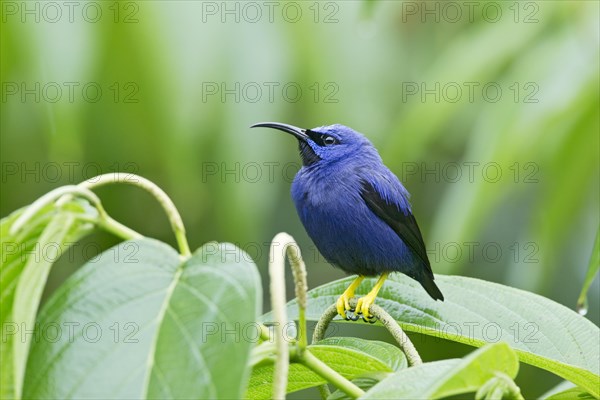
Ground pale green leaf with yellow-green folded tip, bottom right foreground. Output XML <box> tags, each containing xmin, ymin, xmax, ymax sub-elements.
<box><xmin>362</xmin><ymin>343</ymin><xmax>519</xmax><ymax>399</ymax></box>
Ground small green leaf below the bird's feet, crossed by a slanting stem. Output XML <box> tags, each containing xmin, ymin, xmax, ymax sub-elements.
<box><xmin>245</xmin><ymin>338</ymin><xmax>398</xmax><ymax>399</ymax></box>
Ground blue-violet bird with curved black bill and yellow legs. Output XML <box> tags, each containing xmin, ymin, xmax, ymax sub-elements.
<box><xmin>251</xmin><ymin>122</ymin><xmax>444</xmax><ymax>322</ymax></box>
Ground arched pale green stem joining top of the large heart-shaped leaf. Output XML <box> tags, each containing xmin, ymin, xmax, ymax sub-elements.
<box><xmin>78</xmin><ymin>172</ymin><xmax>192</xmax><ymax>258</ymax></box>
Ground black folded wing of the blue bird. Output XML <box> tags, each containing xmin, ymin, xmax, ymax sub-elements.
<box><xmin>361</xmin><ymin>180</ymin><xmax>433</xmax><ymax>274</ymax></box>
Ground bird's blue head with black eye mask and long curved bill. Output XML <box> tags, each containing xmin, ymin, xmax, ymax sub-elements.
<box><xmin>251</xmin><ymin>122</ymin><xmax>377</xmax><ymax>166</ymax></box>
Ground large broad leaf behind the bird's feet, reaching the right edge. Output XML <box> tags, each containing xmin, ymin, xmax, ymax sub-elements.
<box><xmin>272</xmin><ymin>274</ymin><xmax>600</xmax><ymax>396</ymax></box>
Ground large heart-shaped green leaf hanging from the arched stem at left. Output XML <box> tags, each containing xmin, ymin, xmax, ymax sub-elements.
<box><xmin>25</xmin><ymin>239</ymin><xmax>262</xmax><ymax>399</ymax></box>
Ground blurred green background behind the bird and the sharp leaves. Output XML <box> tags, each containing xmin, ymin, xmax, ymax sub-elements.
<box><xmin>0</xmin><ymin>1</ymin><xmax>600</xmax><ymax>397</ymax></box>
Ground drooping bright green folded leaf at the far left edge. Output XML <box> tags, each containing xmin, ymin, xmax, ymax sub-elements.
<box><xmin>0</xmin><ymin>200</ymin><xmax>97</xmax><ymax>399</ymax></box>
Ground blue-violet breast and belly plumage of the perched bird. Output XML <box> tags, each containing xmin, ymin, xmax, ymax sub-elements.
<box><xmin>292</xmin><ymin>165</ymin><xmax>417</xmax><ymax>276</ymax></box>
